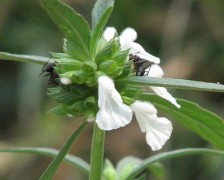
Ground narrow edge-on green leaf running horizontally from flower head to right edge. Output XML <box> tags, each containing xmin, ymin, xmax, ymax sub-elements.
<box><xmin>116</xmin><ymin>76</ymin><xmax>224</xmax><ymax>92</ymax></box>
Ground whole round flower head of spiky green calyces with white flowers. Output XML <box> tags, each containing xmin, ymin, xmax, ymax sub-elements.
<box><xmin>49</xmin><ymin>27</ymin><xmax>180</xmax><ymax>150</ymax></box>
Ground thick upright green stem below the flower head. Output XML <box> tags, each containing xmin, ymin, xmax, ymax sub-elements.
<box><xmin>89</xmin><ymin>123</ymin><xmax>105</xmax><ymax>180</ymax></box>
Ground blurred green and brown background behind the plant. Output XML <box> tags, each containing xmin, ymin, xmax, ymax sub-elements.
<box><xmin>0</xmin><ymin>0</ymin><xmax>224</xmax><ymax>180</ymax></box>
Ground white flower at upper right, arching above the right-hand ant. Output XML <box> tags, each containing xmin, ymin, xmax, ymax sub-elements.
<box><xmin>120</xmin><ymin>28</ymin><xmax>160</xmax><ymax>64</ymax></box>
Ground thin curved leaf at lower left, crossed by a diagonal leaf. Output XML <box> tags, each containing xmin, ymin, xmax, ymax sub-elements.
<box><xmin>0</xmin><ymin>147</ymin><xmax>90</xmax><ymax>175</ymax></box>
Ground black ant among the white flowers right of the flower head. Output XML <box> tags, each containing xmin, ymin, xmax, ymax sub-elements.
<box><xmin>129</xmin><ymin>54</ymin><xmax>153</xmax><ymax>76</ymax></box>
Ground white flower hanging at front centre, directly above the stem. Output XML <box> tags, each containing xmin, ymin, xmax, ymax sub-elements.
<box><xmin>96</xmin><ymin>76</ymin><xmax>133</xmax><ymax>130</ymax></box>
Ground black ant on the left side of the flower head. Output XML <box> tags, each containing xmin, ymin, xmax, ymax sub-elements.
<box><xmin>39</xmin><ymin>62</ymin><xmax>59</xmax><ymax>85</ymax></box>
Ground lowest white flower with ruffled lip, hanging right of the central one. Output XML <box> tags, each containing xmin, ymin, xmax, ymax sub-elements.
<box><xmin>130</xmin><ymin>101</ymin><xmax>173</xmax><ymax>151</ymax></box>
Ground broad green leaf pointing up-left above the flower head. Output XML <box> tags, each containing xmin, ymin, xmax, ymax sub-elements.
<box><xmin>41</xmin><ymin>0</ymin><xmax>90</xmax><ymax>58</ymax></box>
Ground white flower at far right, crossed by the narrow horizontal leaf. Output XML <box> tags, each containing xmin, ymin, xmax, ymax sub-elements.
<box><xmin>148</xmin><ymin>64</ymin><xmax>180</xmax><ymax>108</ymax></box>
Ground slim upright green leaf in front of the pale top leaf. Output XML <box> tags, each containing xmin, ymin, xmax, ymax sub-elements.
<box><xmin>90</xmin><ymin>6</ymin><xmax>113</xmax><ymax>57</ymax></box>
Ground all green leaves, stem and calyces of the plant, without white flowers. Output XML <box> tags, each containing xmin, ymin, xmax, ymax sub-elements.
<box><xmin>0</xmin><ymin>0</ymin><xmax>224</xmax><ymax>180</ymax></box>
